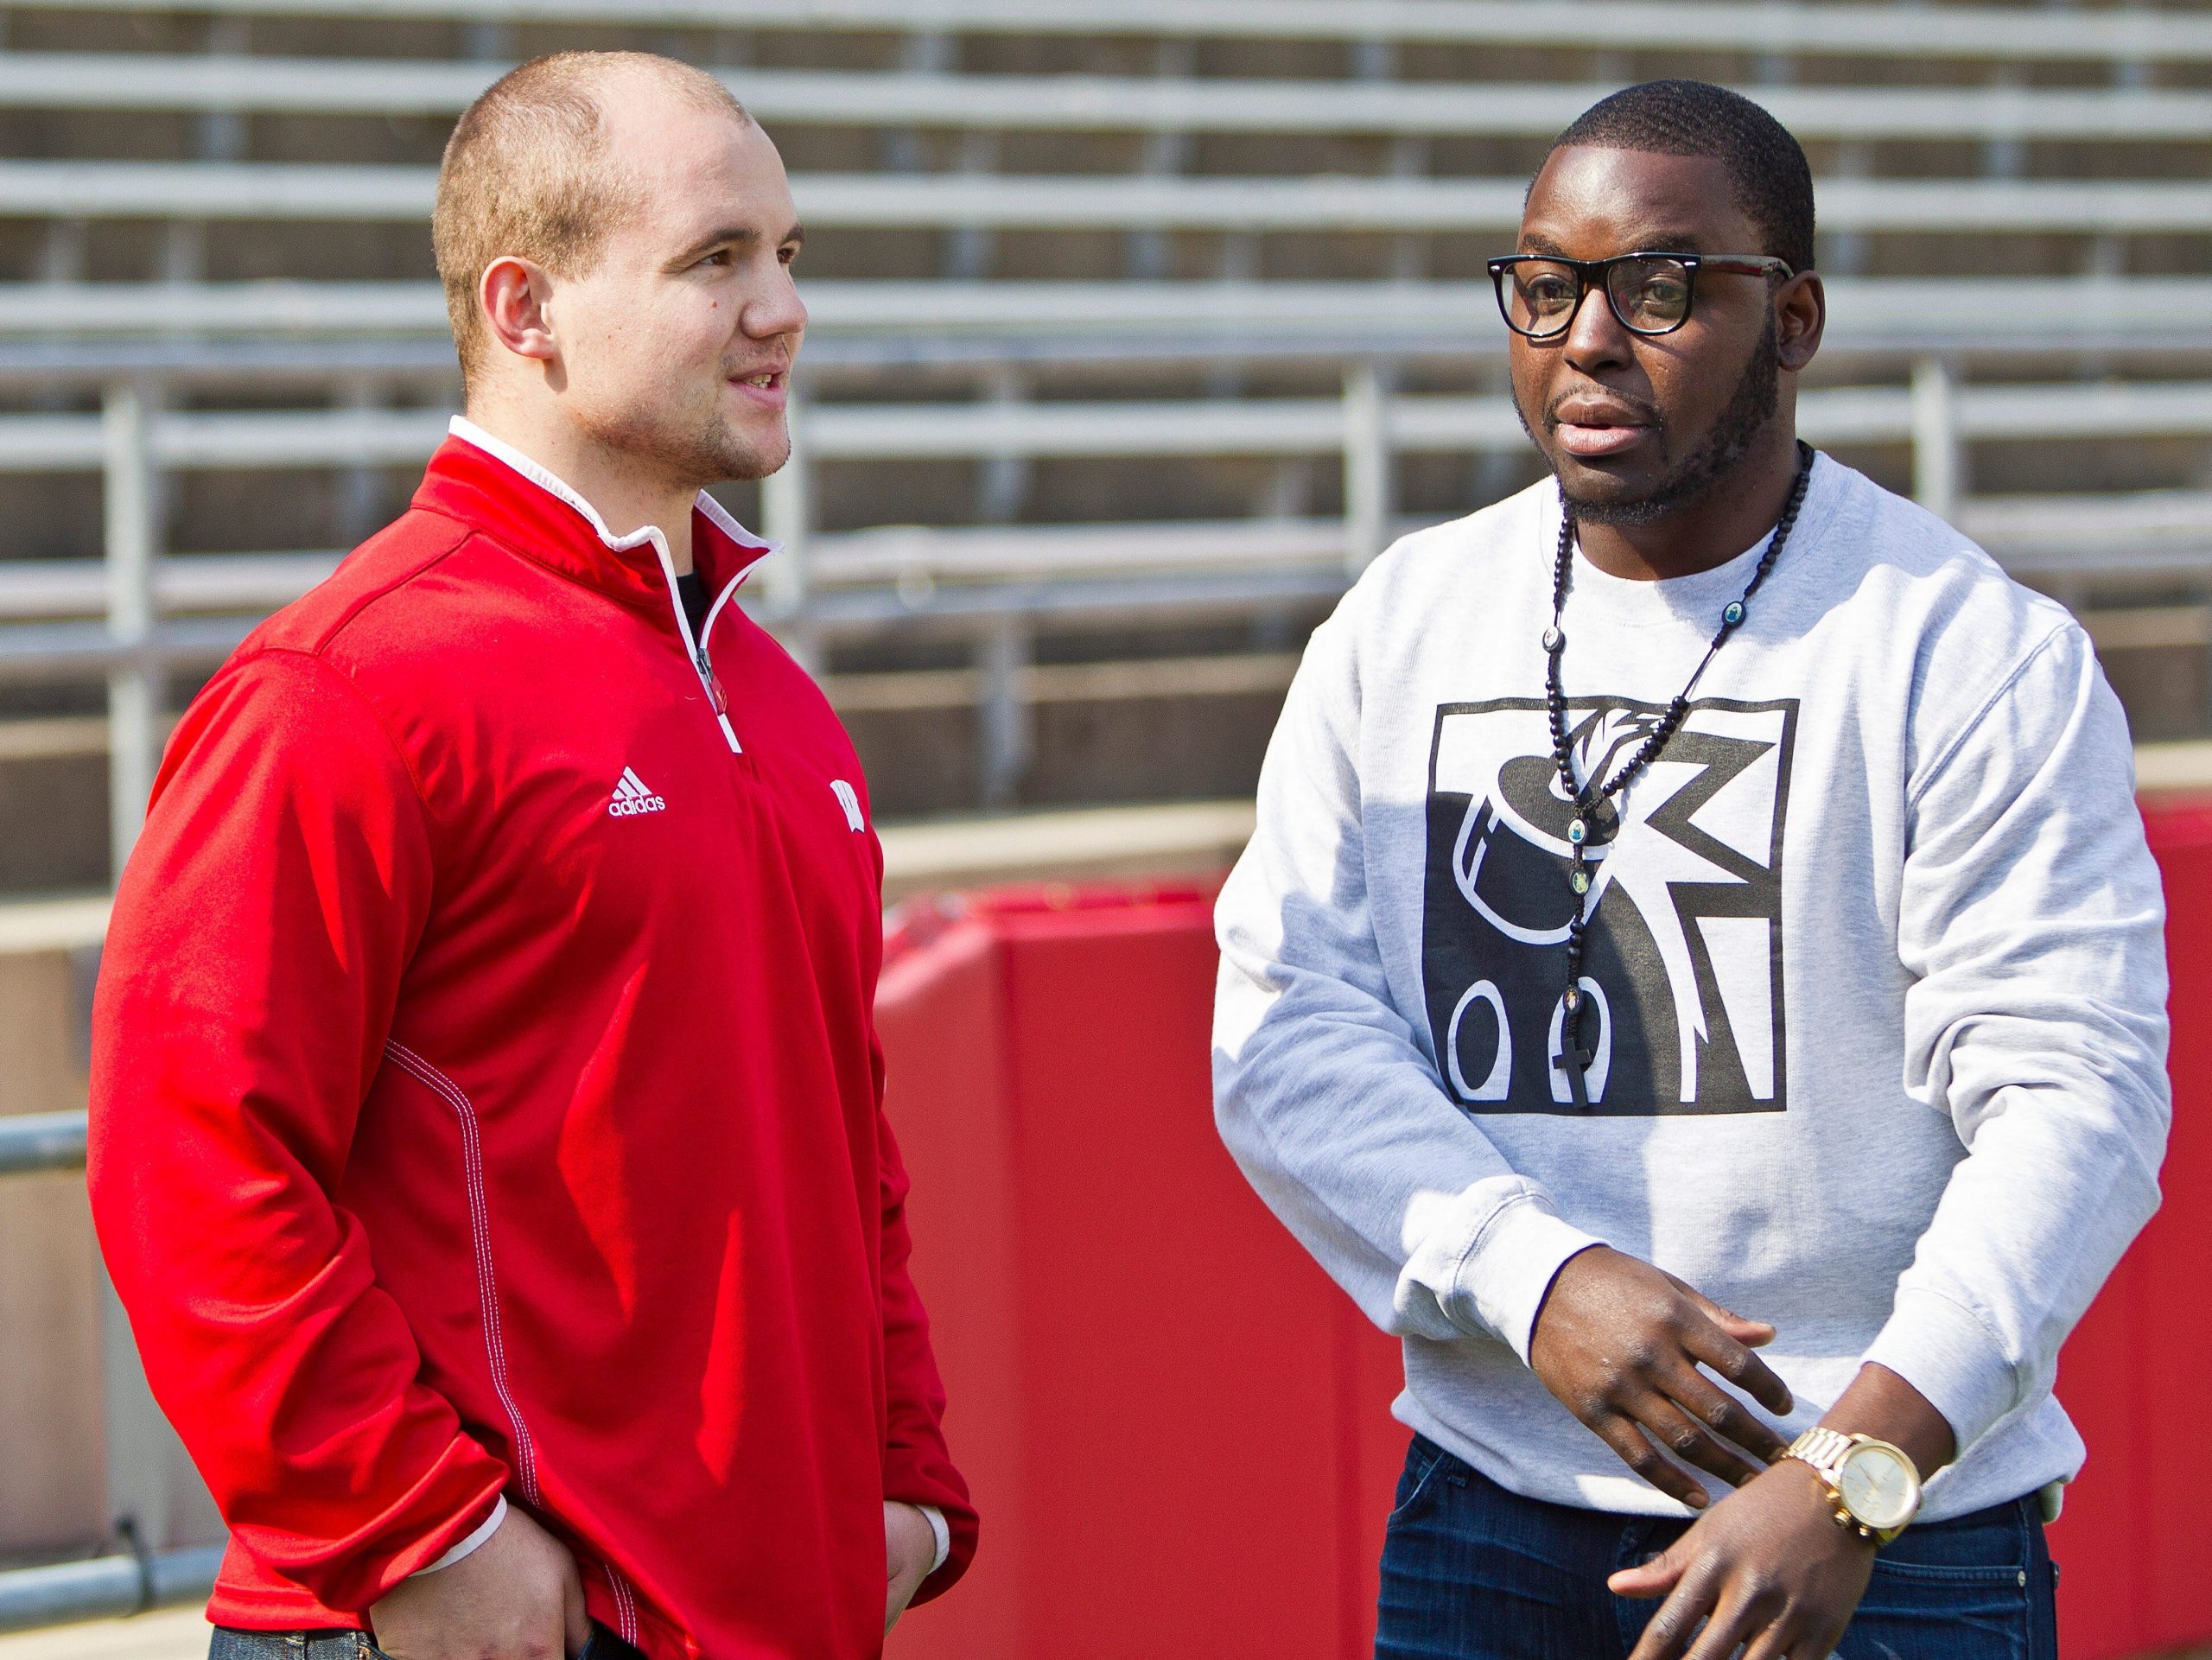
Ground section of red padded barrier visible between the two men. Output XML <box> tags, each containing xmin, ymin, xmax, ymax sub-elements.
<box><xmin>876</xmin><ymin>887</ymin><xmax>1405</xmax><ymax>1660</ymax></box>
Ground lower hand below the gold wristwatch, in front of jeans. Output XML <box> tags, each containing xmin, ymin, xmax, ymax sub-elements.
<box><xmin>1606</xmin><ymin>1459</ymin><xmax>1873</xmax><ymax>1660</ymax></box>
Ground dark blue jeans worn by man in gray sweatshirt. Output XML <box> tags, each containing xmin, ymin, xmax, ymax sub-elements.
<box><xmin>1376</xmin><ymin>1434</ymin><xmax>2059</xmax><ymax>1660</ymax></box>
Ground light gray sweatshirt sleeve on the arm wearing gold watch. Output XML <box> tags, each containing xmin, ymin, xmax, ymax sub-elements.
<box><xmin>1865</xmin><ymin>622</ymin><xmax>2172</xmax><ymax>1452</ymax></box>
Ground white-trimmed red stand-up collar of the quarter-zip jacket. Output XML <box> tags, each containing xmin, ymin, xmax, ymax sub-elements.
<box><xmin>414</xmin><ymin>417</ymin><xmax>777</xmax><ymax>624</ymax></box>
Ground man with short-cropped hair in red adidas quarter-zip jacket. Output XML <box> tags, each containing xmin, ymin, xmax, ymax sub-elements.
<box><xmin>91</xmin><ymin>53</ymin><xmax>976</xmax><ymax>1660</ymax></box>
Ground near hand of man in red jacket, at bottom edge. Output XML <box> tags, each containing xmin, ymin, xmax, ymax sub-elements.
<box><xmin>370</xmin><ymin>1505</ymin><xmax>588</xmax><ymax>1660</ymax></box>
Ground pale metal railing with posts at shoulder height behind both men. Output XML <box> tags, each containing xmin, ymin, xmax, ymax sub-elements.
<box><xmin>0</xmin><ymin>356</ymin><xmax>2212</xmax><ymax>814</ymax></box>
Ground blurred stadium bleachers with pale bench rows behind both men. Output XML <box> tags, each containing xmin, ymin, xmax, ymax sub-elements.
<box><xmin>0</xmin><ymin>0</ymin><xmax>2212</xmax><ymax>886</ymax></box>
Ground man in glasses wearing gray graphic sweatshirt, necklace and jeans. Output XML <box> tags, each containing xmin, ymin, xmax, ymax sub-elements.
<box><xmin>1214</xmin><ymin>82</ymin><xmax>2170</xmax><ymax>1660</ymax></box>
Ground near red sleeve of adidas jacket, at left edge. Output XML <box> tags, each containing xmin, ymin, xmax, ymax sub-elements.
<box><xmin>88</xmin><ymin>651</ymin><xmax>506</xmax><ymax>1612</ymax></box>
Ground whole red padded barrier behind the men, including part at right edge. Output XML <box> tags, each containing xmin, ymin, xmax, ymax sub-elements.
<box><xmin>878</xmin><ymin>836</ymin><xmax>2212</xmax><ymax>1660</ymax></box>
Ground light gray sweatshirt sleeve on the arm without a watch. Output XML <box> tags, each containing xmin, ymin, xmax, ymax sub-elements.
<box><xmin>1214</xmin><ymin>584</ymin><xmax>1599</xmax><ymax>1359</ymax></box>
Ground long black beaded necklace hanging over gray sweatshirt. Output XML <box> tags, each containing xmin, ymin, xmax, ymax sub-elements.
<box><xmin>1544</xmin><ymin>441</ymin><xmax>1814</xmax><ymax>1111</ymax></box>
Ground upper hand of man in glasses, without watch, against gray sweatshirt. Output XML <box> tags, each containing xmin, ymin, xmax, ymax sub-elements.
<box><xmin>1529</xmin><ymin>1246</ymin><xmax>1789</xmax><ymax>1510</ymax></box>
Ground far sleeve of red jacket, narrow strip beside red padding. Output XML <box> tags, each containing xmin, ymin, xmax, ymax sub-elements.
<box><xmin>876</xmin><ymin>1093</ymin><xmax>976</xmax><ymax>1602</ymax></box>
